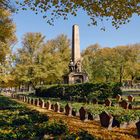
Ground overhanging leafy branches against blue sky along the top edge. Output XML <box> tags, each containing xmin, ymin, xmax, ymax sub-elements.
<box><xmin>16</xmin><ymin>0</ymin><xmax>140</xmax><ymax>28</ymax></box>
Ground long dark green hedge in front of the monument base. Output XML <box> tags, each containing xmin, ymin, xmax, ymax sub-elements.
<box><xmin>35</xmin><ymin>83</ymin><xmax>122</xmax><ymax>100</ymax></box>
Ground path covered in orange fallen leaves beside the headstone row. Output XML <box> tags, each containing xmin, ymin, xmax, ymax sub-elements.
<box><xmin>5</xmin><ymin>95</ymin><xmax>137</xmax><ymax>140</ymax></box>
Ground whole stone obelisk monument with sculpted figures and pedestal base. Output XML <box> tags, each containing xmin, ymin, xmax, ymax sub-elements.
<box><xmin>64</xmin><ymin>25</ymin><xmax>88</xmax><ymax>84</ymax></box>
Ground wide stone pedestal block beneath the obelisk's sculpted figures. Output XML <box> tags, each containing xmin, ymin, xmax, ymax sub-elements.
<box><xmin>64</xmin><ymin>72</ymin><xmax>88</xmax><ymax>84</ymax></box>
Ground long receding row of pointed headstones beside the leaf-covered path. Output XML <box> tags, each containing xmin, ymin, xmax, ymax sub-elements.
<box><xmin>11</xmin><ymin>94</ymin><xmax>140</xmax><ymax>136</ymax></box>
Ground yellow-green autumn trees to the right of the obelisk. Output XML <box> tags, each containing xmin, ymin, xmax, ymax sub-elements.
<box><xmin>82</xmin><ymin>44</ymin><xmax>140</xmax><ymax>83</ymax></box>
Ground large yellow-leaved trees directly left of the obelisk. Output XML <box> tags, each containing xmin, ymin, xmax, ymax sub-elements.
<box><xmin>13</xmin><ymin>33</ymin><xmax>70</xmax><ymax>88</ymax></box>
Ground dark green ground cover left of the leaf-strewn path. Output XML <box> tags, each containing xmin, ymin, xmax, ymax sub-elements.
<box><xmin>0</xmin><ymin>96</ymin><xmax>95</xmax><ymax>140</ymax></box>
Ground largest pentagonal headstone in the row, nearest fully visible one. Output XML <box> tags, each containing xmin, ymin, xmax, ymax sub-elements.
<box><xmin>99</xmin><ymin>111</ymin><xmax>113</xmax><ymax>129</ymax></box>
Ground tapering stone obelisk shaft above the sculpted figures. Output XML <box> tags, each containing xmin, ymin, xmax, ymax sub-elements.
<box><xmin>72</xmin><ymin>25</ymin><xmax>81</xmax><ymax>64</ymax></box>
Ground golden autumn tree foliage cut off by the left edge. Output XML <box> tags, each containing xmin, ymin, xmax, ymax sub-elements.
<box><xmin>0</xmin><ymin>5</ymin><xmax>16</xmax><ymax>87</ymax></box>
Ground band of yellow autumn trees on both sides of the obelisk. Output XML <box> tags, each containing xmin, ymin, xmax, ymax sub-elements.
<box><xmin>1</xmin><ymin>33</ymin><xmax>140</xmax><ymax>89</ymax></box>
